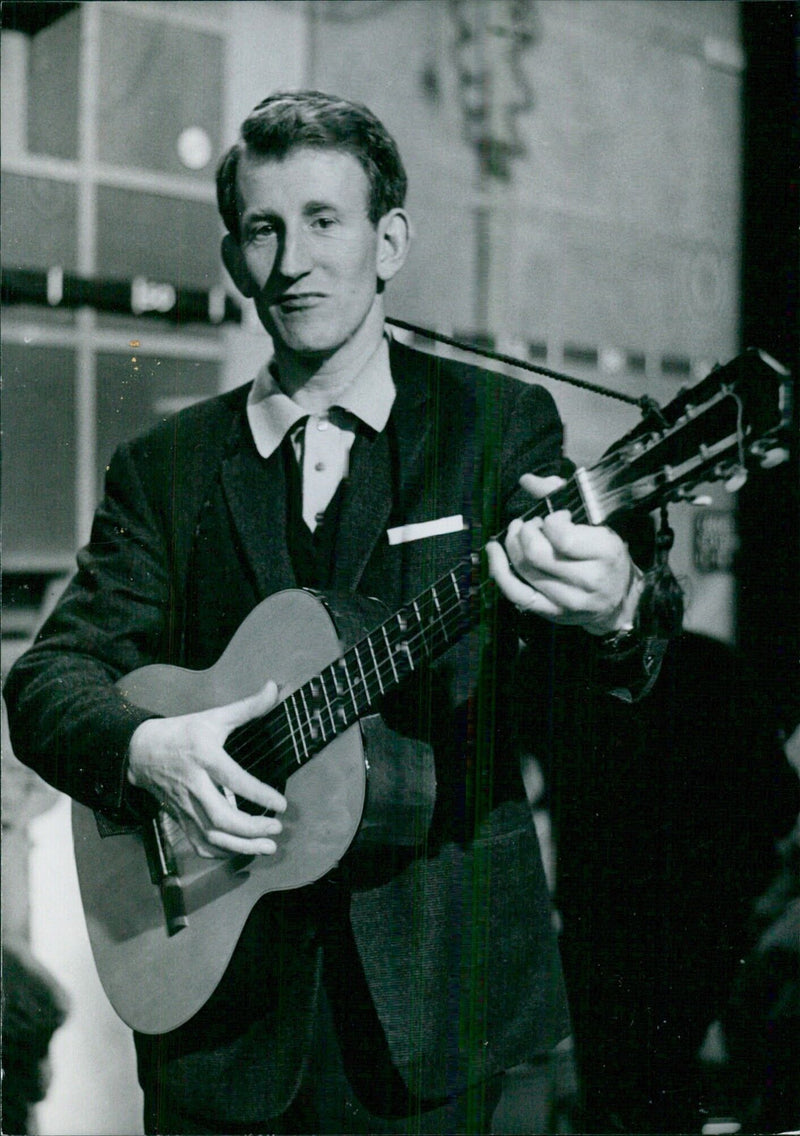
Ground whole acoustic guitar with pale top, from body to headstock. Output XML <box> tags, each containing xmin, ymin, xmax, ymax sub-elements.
<box><xmin>73</xmin><ymin>350</ymin><xmax>791</xmax><ymax>1034</ymax></box>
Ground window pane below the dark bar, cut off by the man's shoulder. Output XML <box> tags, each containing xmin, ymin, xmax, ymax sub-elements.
<box><xmin>98</xmin><ymin>350</ymin><xmax>219</xmax><ymax>487</ymax></box>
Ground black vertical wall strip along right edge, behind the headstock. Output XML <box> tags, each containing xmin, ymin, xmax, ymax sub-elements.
<box><xmin>738</xmin><ymin>0</ymin><xmax>800</xmax><ymax>730</ymax></box>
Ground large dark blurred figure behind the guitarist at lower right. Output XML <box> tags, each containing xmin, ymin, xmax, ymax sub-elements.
<box><xmin>522</xmin><ymin>617</ymin><xmax>800</xmax><ymax>1133</ymax></box>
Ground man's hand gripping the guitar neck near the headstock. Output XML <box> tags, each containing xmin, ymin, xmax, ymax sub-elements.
<box><xmin>486</xmin><ymin>474</ymin><xmax>642</xmax><ymax>635</ymax></box>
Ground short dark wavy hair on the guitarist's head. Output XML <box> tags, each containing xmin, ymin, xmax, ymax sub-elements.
<box><xmin>217</xmin><ymin>91</ymin><xmax>408</xmax><ymax>241</ymax></box>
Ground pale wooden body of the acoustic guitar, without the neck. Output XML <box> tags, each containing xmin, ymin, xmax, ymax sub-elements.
<box><xmin>73</xmin><ymin>591</ymin><xmax>435</xmax><ymax>1034</ymax></box>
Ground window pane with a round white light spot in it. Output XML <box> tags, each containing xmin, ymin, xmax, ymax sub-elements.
<box><xmin>98</xmin><ymin>9</ymin><xmax>223</xmax><ymax>181</ymax></box>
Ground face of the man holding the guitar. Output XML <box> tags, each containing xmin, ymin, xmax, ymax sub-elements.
<box><xmin>228</xmin><ymin>148</ymin><xmax>381</xmax><ymax>357</ymax></box>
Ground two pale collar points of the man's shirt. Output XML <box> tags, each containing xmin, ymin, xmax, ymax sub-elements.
<box><xmin>247</xmin><ymin>335</ymin><xmax>395</xmax><ymax>458</ymax></box>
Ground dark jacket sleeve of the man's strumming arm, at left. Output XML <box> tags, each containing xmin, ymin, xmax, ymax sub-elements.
<box><xmin>5</xmin><ymin>446</ymin><xmax>169</xmax><ymax>824</ymax></box>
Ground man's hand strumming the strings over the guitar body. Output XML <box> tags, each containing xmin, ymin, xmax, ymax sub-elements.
<box><xmin>127</xmin><ymin>682</ymin><xmax>286</xmax><ymax>857</ymax></box>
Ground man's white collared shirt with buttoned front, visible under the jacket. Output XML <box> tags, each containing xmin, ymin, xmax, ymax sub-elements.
<box><xmin>247</xmin><ymin>335</ymin><xmax>395</xmax><ymax>532</ymax></box>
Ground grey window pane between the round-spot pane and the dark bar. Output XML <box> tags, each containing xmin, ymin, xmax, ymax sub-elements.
<box><xmin>98</xmin><ymin>186</ymin><xmax>222</xmax><ymax>289</ymax></box>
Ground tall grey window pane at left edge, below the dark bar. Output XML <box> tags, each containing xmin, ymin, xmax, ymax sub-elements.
<box><xmin>2</xmin><ymin>343</ymin><xmax>75</xmax><ymax>560</ymax></box>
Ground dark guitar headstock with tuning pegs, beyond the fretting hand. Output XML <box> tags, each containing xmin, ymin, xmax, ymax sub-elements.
<box><xmin>580</xmin><ymin>348</ymin><xmax>792</xmax><ymax>524</ymax></box>
